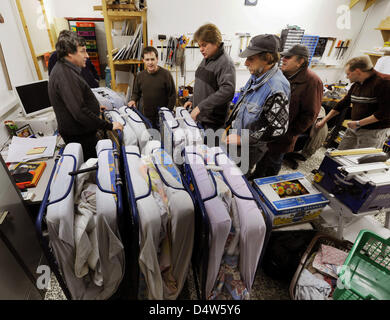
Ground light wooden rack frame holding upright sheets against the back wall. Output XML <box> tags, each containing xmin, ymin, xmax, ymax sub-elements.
<box><xmin>94</xmin><ymin>0</ymin><xmax>148</xmax><ymax>93</ymax></box>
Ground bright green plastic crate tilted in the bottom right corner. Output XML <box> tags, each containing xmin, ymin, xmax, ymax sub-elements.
<box><xmin>333</xmin><ymin>230</ymin><xmax>390</xmax><ymax>300</ymax></box>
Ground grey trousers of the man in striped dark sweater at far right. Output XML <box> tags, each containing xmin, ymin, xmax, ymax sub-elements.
<box><xmin>337</xmin><ymin>128</ymin><xmax>390</xmax><ymax>150</ymax></box>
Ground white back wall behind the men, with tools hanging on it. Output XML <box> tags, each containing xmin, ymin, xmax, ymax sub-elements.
<box><xmin>148</xmin><ymin>0</ymin><xmax>367</xmax><ymax>88</ymax></box>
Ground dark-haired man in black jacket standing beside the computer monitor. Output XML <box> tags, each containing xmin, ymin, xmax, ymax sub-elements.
<box><xmin>49</xmin><ymin>31</ymin><xmax>123</xmax><ymax>160</ymax></box>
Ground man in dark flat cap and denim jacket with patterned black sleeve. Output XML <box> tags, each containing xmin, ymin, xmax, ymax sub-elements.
<box><xmin>224</xmin><ymin>34</ymin><xmax>290</xmax><ymax>176</ymax></box>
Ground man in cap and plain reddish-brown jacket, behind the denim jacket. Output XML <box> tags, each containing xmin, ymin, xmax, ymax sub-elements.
<box><xmin>253</xmin><ymin>45</ymin><xmax>323</xmax><ymax>178</ymax></box>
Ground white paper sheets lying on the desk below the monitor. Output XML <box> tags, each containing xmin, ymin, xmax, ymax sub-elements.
<box><xmin>6</xmin><ymin>136</ymin><xmax>57</xmax><ymax>162</ymax></box>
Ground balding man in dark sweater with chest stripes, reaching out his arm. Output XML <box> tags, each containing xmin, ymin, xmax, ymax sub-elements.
<box><xmin>316</xmin><ymin>56</ymin><xmax>390</xmax><ymax>150</ymax></box>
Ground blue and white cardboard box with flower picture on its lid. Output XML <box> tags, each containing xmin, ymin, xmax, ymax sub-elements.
<box><xmin>254</xmin><ymin>172</ymin><xmax>329</xmax><ymax>227</ymax></box>
